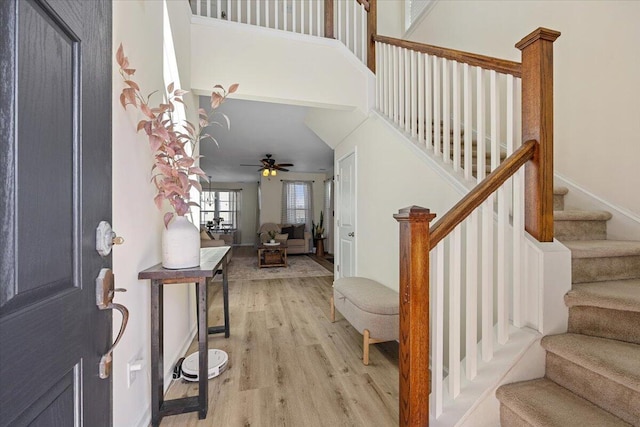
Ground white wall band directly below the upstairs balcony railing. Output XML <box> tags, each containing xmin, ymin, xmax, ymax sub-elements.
<box><xmin>191</xmin><ymin>17</ymin><xmax>373</xmax><ymax>111</ymax></box>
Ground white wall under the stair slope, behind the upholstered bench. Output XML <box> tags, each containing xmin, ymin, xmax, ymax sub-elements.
<box><xmin>335</xmin><ymin>114</ymin><xmax>461</xmax><ymax>290</ymax></box>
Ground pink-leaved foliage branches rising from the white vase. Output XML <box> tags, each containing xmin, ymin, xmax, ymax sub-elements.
<box><xmin>116</xmin><ymin>44</ymin><xmax>238</xmax><ymax>226</ymax></box>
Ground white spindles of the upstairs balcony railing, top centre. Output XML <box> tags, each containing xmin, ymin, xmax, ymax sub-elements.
<box><xmin>191</xmin><ymin>0</ymin><xmax>368</xmax><ymax>64</ymax></box>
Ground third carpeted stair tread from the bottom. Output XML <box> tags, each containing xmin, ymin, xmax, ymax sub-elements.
<box><xmin>564</xmin><ymin>279</ymin><xmax>640</xmax><ymax>314</ymax></box>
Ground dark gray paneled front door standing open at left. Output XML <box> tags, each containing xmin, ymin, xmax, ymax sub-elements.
<box><xmin>0</xmin><ymin>0</ymin><xmax>111</xmax><ymax>427</ymax></box>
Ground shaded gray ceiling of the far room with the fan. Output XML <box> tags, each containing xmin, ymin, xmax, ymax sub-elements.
<box><xmin>200</xmin><ymin>96</ymin><xmax>333</xmax><ymax>182</ymax></box>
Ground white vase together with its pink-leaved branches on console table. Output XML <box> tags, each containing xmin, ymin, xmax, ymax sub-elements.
<box><xmin>116</xmin><ymin>44</ymin><xmax>238</xmax><ymax>268</ymax></box>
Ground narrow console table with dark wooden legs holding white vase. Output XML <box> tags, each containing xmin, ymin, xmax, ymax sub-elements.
<box><xmin>138</xmin><ymin>246</ymin><xmax>230</xmax><ymax>427</ymax></box>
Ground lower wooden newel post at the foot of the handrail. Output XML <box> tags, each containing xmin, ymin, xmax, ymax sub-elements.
<box><xmin>394</xmin><ymin>206</ymin><xmax>436</xmax><ymax>427</ymax></box>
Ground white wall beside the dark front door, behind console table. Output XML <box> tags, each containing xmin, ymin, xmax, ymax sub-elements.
<box><xmin>112</xmin><ymin>0</ymin><xmax>195</xmax><ymax>426</ymax></box>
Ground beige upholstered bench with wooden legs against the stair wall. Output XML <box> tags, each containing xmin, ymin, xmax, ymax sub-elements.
<box><xmin>331</xmin><ymin>277</ymin><xmax>400</xmax><ymax>365</ymax></box>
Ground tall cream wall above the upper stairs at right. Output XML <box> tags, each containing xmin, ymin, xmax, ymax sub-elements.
<box><xmin>411</xmin><ymin>0</ymin><xmax>640</xmax><ymax>219</ymax></box>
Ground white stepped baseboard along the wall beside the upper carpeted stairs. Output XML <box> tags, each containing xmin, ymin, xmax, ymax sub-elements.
<box><xmin>554</xmin><ymin>173</ymin><xmax>640</xmax><ymax>240</ymax></box>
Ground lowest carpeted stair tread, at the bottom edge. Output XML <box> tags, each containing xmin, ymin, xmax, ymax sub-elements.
<box><xmin>496</xmin><ymin>378</ymin><xmax>631</xmax><ymax>427</ymax></box>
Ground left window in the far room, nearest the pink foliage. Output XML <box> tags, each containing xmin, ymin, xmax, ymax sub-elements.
<box><xmin>200</xmin><ymin>189</ymin><xmax>241</xmax><ymax>229</ymax></box>
